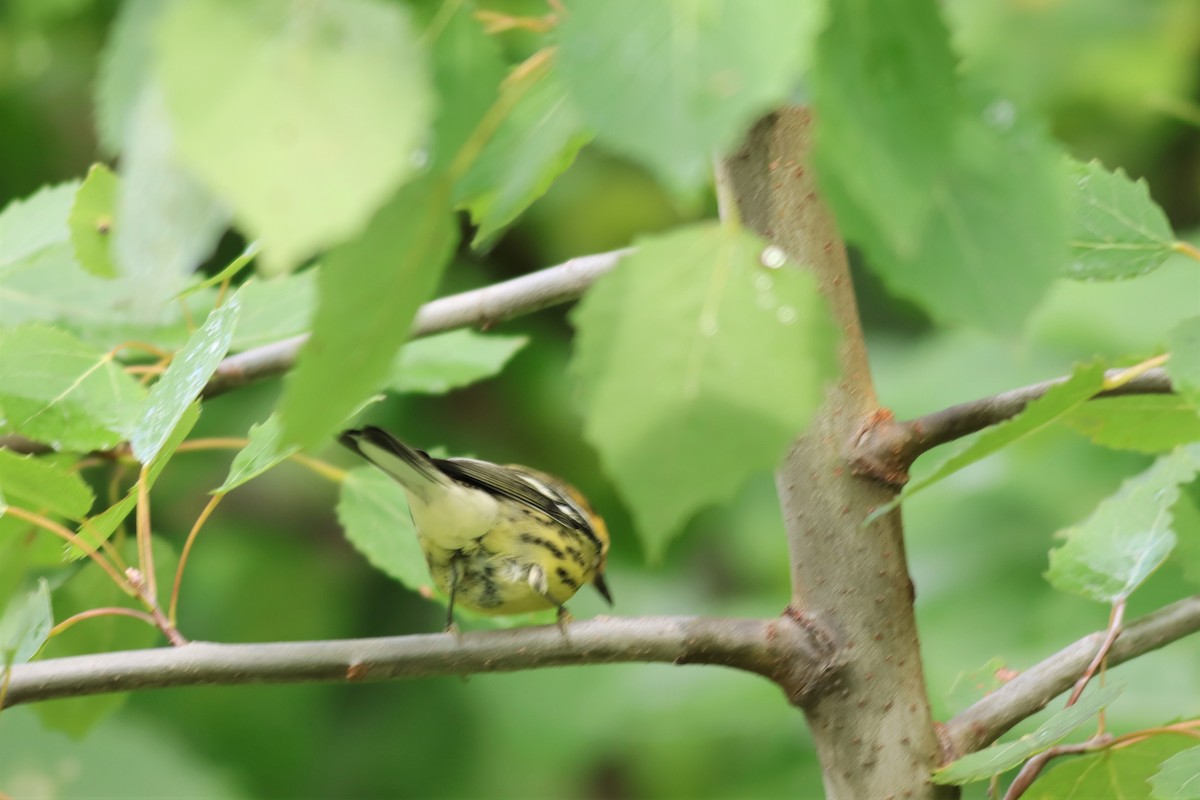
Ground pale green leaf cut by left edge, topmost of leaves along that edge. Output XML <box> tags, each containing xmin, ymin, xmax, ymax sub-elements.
<box><xmin>0</xmin><ymin>181</ymin><xmax>80</xmax><ymax>272</ymax></box>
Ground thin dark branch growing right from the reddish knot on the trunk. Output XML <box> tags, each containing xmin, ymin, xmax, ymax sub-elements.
<box><xmin>848</xmin><ymin>368</ymin><xmax>1172</xmax><ymax>486</ymax></box>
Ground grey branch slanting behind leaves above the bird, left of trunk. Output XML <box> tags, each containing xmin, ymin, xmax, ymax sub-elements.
<box><xmin>204</xmin><ymin>248</ymin><xmax>632</xmax><ymax>397</ymax></box>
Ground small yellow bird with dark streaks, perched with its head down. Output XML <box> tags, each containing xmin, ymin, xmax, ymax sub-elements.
<box><xmin>338</xmin><ymin>427</ymin><xmax>612</xmax><ymax>630</ymax></box>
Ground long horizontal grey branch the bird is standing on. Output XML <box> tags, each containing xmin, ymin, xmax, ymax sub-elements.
<box><xmin>2</xmin><ymin>615</ymin><xmax>834</xmax><ymax>706</ymax></box>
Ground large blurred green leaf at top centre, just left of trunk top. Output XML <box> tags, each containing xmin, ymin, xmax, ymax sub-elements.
<box><xmin>558</xmin><ymin>0</ymin><xmax>824</xmax><ymax>190</ymax></box>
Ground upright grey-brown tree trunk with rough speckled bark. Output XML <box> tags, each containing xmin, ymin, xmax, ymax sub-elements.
<box><xmin>724</xmin><ymin>109</ymin><xmax>956</xmax><ymax>800</ymax></box>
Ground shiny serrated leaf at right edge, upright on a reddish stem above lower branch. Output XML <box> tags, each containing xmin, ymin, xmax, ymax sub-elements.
<box><xmin>1046</xmin><ymin>445</ymin><xmax>1200</xmax><ymax>603</ymax></box>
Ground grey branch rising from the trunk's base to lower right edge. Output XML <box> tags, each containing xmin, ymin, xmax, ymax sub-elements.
<box><xmin>942</xmin><ymin>595</ymin><xmax>1200</xmax><ymax>758</ymax></box>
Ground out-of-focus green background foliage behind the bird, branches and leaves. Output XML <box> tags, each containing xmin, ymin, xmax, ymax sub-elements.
<box><xmin>0</xmin><ymin>0</ymin><xmax>1200</xmax><ymax>798</ymax></box>
